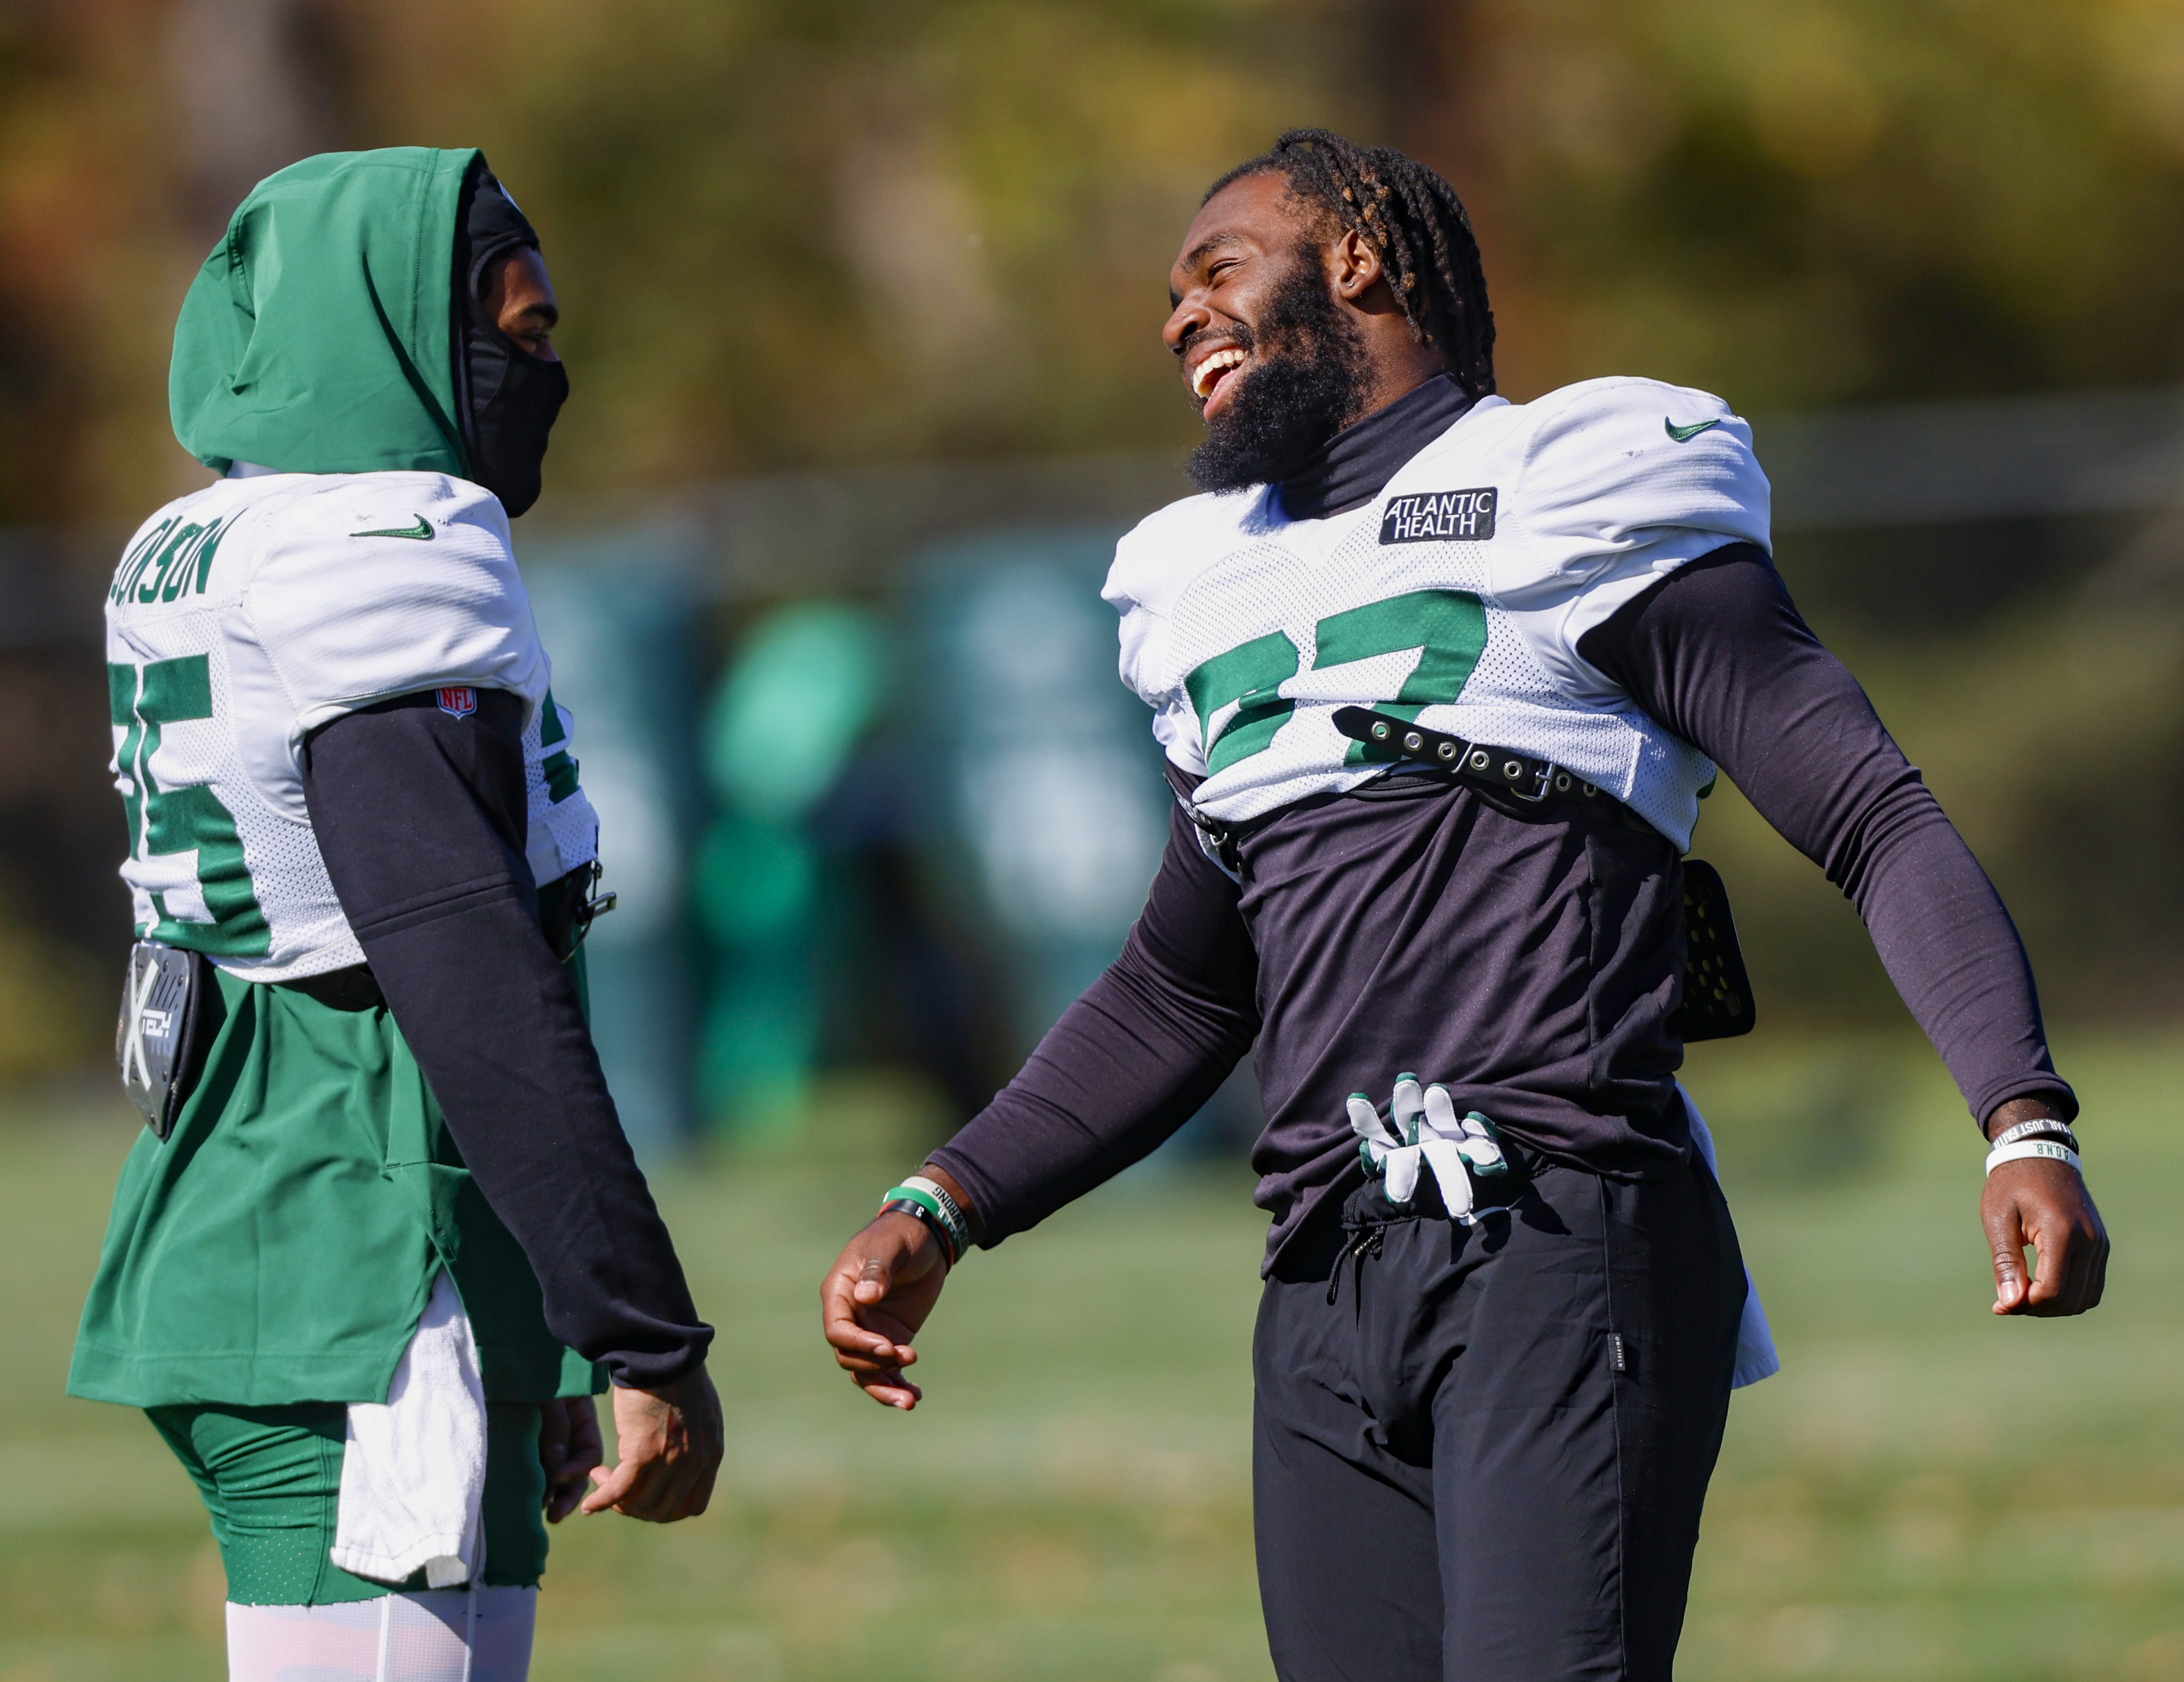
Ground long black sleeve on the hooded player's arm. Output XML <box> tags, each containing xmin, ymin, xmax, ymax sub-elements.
<box><xmin>303</xmin><ymin>690</ymin><xmax>712</xmax><ymax>1389</ymax></box>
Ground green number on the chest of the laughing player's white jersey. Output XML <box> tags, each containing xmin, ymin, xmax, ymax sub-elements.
<box><xmin>1184</xmin><ymin>590</ymin><xmax>1487</xmax><ymax>776</ymax></box>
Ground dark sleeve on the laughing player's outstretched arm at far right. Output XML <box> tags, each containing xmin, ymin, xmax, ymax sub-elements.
<box><xmin>1577</xmin><ymin>544</ymin><xmax>2077</xmax><ymax>1121</ymax></box>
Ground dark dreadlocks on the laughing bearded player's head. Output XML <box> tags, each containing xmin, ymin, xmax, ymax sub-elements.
<box><xmin>1199</xmin><ymin>129</ymin><xmax>1494</xmax><ymax>397</ymax></box>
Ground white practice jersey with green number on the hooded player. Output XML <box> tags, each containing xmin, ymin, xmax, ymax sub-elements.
<box><xmin>107</xmin><ymin>472</ymin><xmax>598</xmax><ymax>981</ymax></box>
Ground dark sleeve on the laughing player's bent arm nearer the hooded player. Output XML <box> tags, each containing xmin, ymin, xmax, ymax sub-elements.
<box><xmin>933</xmin><ymin>810</ymin><xmax>1258</xmax><ymax>1245</ymax></box>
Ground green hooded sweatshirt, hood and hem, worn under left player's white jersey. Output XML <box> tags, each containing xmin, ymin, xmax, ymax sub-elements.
<box><xmin>70</xmin><ymin>146</ymin><xmax>603</xmax><ymax>1407</ymax></box>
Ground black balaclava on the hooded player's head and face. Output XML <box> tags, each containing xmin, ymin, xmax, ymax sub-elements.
<box><xmin>454</xmin><ymin>157</ymin><xmax>568</xmax><ymax>520</ymax></box>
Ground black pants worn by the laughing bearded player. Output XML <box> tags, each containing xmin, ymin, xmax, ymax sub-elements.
<box><xmin>1251</xmin><ymin>1158</ymin><xmax>1745</xmax><ymax>1682</ymax></box>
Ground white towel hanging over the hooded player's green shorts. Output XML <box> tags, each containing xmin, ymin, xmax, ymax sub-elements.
<box><xmin>330</xmin><ymin>1269</ymin><xmax>485</xmax><ymax>1588</ymax></box>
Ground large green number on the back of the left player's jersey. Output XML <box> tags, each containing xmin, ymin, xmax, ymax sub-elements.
<box><xmin>107</xmin><ymin>653</ymin><xmax>273</xmax><ymax>957</ymax></box>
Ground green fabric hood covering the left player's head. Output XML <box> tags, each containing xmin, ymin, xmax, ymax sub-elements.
<box><xmin>168</xmin><ymin>146</ymin><xmax>478</xmax><ymax>478</ymax></box>
